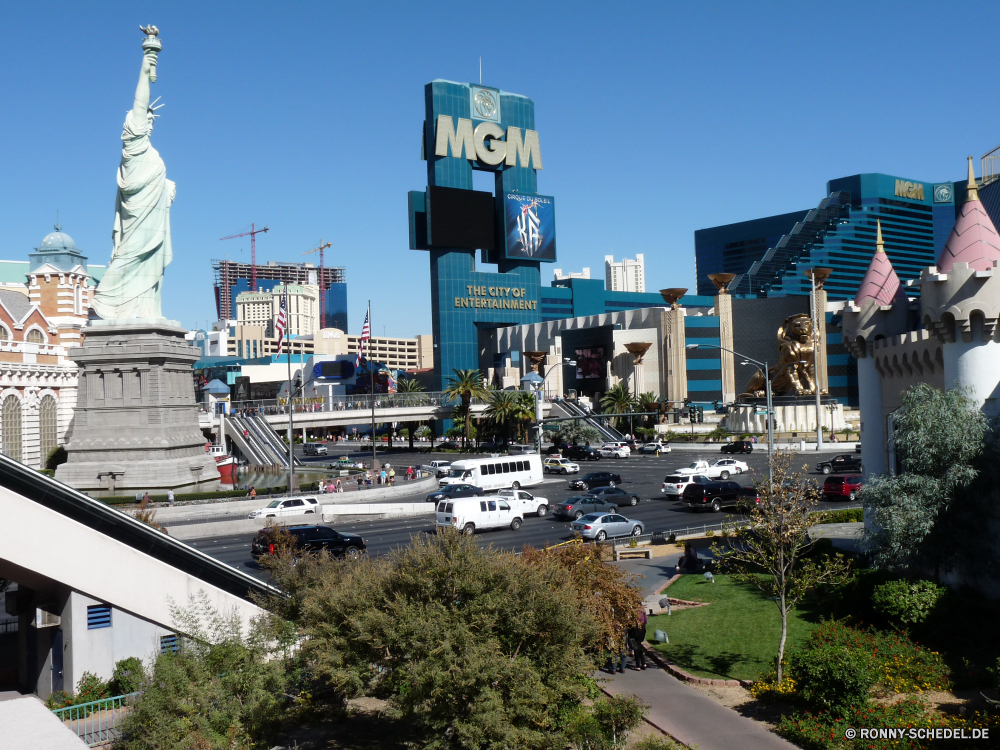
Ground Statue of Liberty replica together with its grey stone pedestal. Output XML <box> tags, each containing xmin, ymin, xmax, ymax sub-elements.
<box><xmin>56</xmin><ymin>26</ymin><xmax>219</xmax><ymax>494</ymax></box>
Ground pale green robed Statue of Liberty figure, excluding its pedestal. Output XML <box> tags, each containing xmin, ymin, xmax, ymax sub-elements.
<box><xmin>93</xmin><ymin>26</ymin><xmax>175</xmax><ymax>320</ymax></box>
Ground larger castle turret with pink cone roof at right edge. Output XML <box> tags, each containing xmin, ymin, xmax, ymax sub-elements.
<box><xmin>920</xmin><ymin>156</ymin><xmax>1000</xmax><ymax>416</ymax></box>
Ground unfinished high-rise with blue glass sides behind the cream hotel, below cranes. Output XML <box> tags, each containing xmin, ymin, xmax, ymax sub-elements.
<box><xmin>212</xmin><ymin>260</ymin><xmax>348</xmax><ymax>332</ymax></box>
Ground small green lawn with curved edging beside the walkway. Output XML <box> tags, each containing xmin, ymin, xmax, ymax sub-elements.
<box><xmin>647</xmin><ymin>574</ymin><xmax>819</xmax><ymax>680</ymax></box>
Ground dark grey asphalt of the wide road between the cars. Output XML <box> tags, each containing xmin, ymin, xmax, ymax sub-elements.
<box><xmin>189</xmin><ymin>446</ymin><xmax>846</xmax><ymax>578</ymax></box>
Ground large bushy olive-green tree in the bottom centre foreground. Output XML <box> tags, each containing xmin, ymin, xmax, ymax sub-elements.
<box><xmin>275</xmin><ymin>531</ymin><xmax>614</xmax><ymax>750</ymax></box>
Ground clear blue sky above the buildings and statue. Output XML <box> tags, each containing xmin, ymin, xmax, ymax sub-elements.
<box><xmin>0</xmin><ymin>2</ymin><xmax>1000</xmax><ymax>336</ymax></box>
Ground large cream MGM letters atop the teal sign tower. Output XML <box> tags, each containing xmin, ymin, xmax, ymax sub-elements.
<box><xmin>434</xmin><ymin>115</ymin><xmax>542</xmax><ymax>169</ymax></box>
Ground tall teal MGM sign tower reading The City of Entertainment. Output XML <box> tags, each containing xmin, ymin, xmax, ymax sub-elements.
<box><xmin>409</xmin><ymin>80</ymin><xmax>556</xmax><ymax>388</ymax></box>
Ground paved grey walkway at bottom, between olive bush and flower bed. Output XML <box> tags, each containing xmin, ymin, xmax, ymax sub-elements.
<box><xmin>600</xmin><ymin>659</ymin><xmax>796</xmax><ymax>750</ymax></box>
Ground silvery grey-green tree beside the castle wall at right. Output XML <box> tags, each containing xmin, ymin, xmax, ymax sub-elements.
<box><xmin>860</xmin><ymin>384</ymin><xmax>1000</xmax><ymax>579</ymax></box>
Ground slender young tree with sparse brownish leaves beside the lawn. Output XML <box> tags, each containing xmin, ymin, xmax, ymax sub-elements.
<box><xmin>712</xmin><ymin>451</ymin><xmax>849</xmax><ymax>683</ymax></box>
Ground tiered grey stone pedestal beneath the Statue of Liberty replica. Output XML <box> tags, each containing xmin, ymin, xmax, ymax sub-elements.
<box><xmin>56</xmin><ymin>319</ymin><xmax>219</xmax><ymax>491</ymax></box>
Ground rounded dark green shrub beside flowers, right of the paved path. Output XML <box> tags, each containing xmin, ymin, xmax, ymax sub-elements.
<box><xmin>793</xmin><ymin>643</ymin><xmax>878</xmax><ymax>712</ymax></box>
